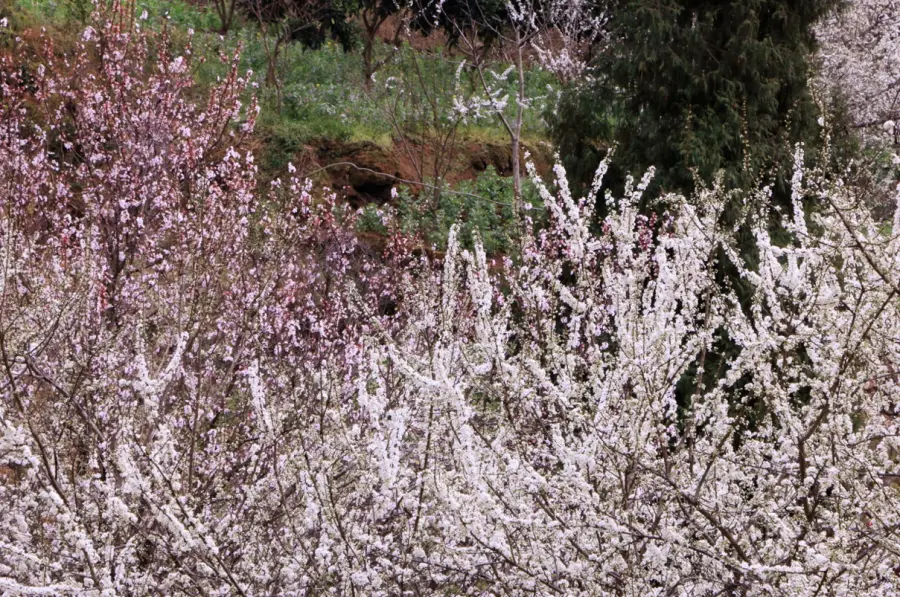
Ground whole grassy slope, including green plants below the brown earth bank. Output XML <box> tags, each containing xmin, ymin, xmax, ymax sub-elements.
<box><xmin>0</xmin><ymin>0</ymin><xmax>556</xmax><ymax>251</ymax></box>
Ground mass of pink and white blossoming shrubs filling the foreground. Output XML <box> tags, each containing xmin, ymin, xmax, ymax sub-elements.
<box><xmin>0</xmin><ymin>4</ymin><xmax>900</xmax><ymax>597</ymax></box>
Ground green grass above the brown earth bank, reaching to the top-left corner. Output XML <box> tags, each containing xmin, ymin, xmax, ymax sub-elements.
<box><xmin>0</xmin><ymin>0</ymin><xmax>556</xmax><ymax>184</ymax></box>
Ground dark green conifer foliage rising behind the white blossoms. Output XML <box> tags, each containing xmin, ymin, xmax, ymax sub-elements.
<box><xmin>555</xmin><ymin>0</ymin><xmax>839</xmax><ymax>201</ymax></box>
